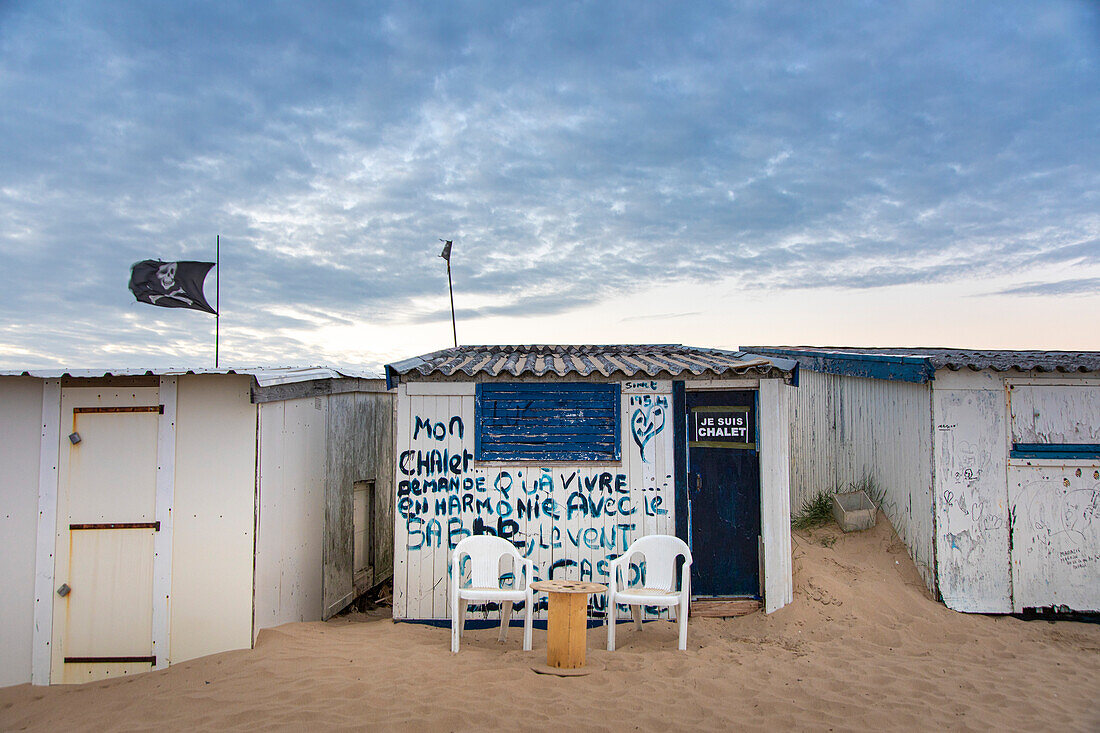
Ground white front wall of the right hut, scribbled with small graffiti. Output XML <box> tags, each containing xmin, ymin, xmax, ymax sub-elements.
<box><xmin>933</xmin><ymin>370</ymin><xmax>1100</xmax><ymax>613</ymax></box>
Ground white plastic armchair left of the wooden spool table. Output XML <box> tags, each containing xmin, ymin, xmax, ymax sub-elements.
<box><xmin>451</xmin><ymin>535</ymin><xmax>535</xmax><ymax>653</ymax></box>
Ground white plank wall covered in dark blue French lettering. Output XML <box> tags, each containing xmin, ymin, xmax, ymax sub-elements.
<box><xmin>394</xmin><ymin>380</ymin><xmax>675</xmax><ymax>620</ymax></box>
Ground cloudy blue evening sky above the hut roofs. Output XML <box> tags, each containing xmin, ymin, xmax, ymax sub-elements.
<box><xmin>0</xmin><ymin>0</ymin><xmax>1100</xmax><ymax>369</ymax></box>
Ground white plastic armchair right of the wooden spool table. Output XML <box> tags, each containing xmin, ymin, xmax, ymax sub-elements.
<box><xmin>607</xmin><ymin>535</ymin><xmax>691</xmax><ymax>652</ymax></box>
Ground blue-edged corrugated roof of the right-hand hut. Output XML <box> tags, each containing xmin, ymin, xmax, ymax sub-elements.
<box><xmin>741</xmin><ymin>347</ymin><xmax>1100</xmax><ymax>373</ymax></box>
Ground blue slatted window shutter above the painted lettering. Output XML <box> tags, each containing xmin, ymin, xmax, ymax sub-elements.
<box><xmin>474</xmin><ymin>382</ymin><xmax>622</xmax><ymax>461</ymax></box>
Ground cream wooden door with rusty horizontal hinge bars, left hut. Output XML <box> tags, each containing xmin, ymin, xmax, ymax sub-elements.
<box><xmin>51</xmin><ymin>387</ymin><xmax>161</xmax><ymax>683</ymax></box>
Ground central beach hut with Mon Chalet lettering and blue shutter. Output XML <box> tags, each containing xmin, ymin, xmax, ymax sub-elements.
<box><xmin>386</xmin><ymin>344</ymin><xmax>796</xmax><ymax>622</ymax></box>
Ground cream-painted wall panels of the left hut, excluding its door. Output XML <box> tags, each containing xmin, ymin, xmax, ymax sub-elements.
<box><xmin>0</xmin><ymin>375</ymin><xmax>363</xmax><ymax>685</ymax></box>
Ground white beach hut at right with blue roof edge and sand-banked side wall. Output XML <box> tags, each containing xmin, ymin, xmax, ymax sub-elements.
<box><xmin>748</xmin><ymin>347</ymin><xmax>1100</xmax><ymax>613</ymax></box>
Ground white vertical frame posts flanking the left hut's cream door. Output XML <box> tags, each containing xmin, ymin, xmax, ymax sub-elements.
<box><xmin>31</xmin><ymin>376</ymin><xmax>177</xmax><ymax>685</ymax></box>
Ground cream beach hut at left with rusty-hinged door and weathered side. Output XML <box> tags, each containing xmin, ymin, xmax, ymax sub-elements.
<box><xmin>0</xmin><ymin>368</ymin><xmax>394</xmax><ymax>685</ymax></box>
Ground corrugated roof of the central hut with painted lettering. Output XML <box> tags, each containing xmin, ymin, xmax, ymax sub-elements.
<box><xmin>386</xmin><ymin>343</ymin><xmax>798</xmax><ymax>384</ymax></box>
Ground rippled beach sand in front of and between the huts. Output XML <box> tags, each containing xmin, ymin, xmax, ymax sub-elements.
<box><xmin>0</xmin><ymin>514</ymin><xmax>1100</xmax><ymax>733</ymax></box>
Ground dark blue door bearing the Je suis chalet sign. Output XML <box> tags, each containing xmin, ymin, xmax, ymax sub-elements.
<box><xmin>685</xmin><ymin>390</ymin><xmax>760</xmax><ymax>598</ymax></box>
